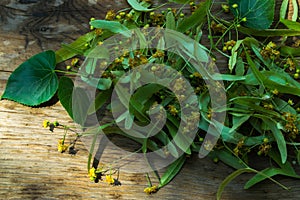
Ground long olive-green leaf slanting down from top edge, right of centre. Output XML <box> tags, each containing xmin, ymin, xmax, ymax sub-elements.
<box><xmin>177</xmin><ymin>0</ymin><xmax>211</xmax><ymax>33</ymax></box>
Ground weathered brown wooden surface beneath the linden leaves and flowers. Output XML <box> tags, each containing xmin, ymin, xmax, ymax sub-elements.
<box><xmin>0</xmin><ymin>0</ymin><xmax>300</xmax><ymax>199</ymax></box>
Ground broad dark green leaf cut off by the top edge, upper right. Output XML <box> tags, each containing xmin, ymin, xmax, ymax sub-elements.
<box><xmin>229</xmin><ymin>0</ymin><xmax>275</xmax><ymax>30</ymax></box>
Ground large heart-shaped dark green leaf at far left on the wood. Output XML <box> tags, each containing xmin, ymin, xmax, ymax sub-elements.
<box><xmin>1</xmin><ymin>51</ymin><xmax>58</xmax><ymax>106</ymax></box>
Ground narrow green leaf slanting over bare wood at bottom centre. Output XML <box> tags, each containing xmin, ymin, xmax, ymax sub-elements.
<box><xmin>158</xmin><ymin>155</ymin><xmax>186</xmax><ymax>188</ymax></box>
